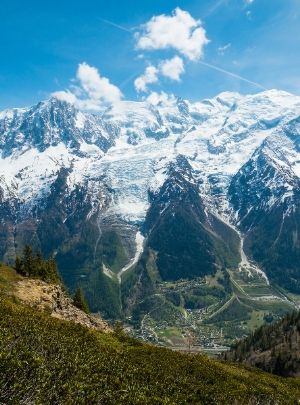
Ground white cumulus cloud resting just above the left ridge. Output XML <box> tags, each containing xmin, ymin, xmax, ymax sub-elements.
<box><xmin>52</xmin><ymin>62</ymin><xmax>123</xmax><ymax>111</ymax></box>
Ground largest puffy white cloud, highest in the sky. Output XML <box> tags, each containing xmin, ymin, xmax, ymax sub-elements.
<box><xmin>136</xmin><ymin>7</ymin><xmax>209</xmax><ymax>61</ymax></box>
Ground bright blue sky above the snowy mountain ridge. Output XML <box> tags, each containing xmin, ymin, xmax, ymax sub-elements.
<box><xmin>0</xmin><ymin>0</ymin><xmax>300</xmax><ymax>109</ymax></box>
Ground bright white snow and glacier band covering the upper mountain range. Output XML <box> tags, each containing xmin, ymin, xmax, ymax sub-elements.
<box><xmin>0</xmin><ymin>90</ymin><xmax>300</xmax><ymax>222</ymax></box>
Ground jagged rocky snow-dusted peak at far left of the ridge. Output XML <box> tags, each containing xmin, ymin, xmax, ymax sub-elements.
<box><xmin>0</xmin><ymin>97</ymin><xmax>118</xmax><ymax>157</ymax></box>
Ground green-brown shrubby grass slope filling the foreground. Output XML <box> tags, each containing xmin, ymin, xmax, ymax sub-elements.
<box><xmin>0</xmin><ymin>267</ymin><xmax>300</xmax><ymax>405</ymax></box>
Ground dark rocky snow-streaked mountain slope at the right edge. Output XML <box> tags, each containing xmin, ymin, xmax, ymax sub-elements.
<box><xmin>229</xmin><ymin>118</ymin><xmax>300</xmax><ymax>292</ymax></box>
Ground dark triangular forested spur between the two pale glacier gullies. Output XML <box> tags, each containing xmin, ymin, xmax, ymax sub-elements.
<box><xmin>144</xmin><ymin>155</ymin><xmax>240</xmax><ymax>280</ymax></box>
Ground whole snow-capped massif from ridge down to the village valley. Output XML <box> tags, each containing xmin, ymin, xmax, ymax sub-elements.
<box><xmin>0</xmin><ymin>90</ymin><xmax>300</xmax><ymax>349</ymax></box>
